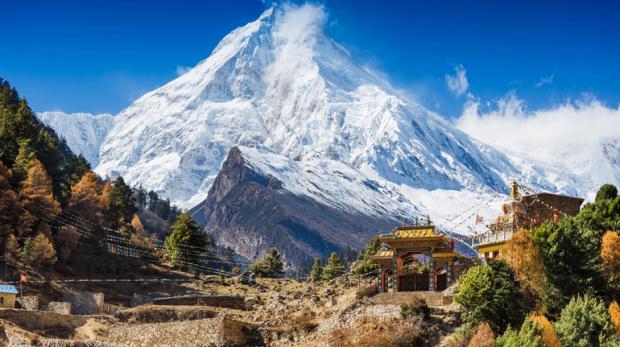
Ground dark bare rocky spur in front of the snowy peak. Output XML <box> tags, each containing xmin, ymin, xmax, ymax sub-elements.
<box><xmin>191</xmin><ymin>147</ymin><xmax>397</xmax><ymax>265</ymax></box>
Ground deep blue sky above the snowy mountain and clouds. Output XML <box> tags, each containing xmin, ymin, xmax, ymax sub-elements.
<box><xmin>0</xmin><ymin>0</ymin><xmax>620</xmax><ymax>117</ymax></box>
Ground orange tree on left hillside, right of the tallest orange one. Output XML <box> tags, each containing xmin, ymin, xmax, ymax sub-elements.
<box><xmin>68</xmin><ymin>172</ymin><xmax>105</xmax><ymax>223</ymax></box>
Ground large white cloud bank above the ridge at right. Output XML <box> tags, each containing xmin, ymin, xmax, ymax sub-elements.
<box><xmin>456</xmin><ymin>92</ymin><xmax>620</xmax><ymax>156</ymax></box>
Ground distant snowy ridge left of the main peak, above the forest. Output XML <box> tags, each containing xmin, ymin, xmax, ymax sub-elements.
<box><xmin>37</xmin><ymin>112</ymin><xmax>114</xmax><ymax>167</ymax></box>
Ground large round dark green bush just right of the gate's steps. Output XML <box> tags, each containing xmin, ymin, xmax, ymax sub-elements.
<box><xmin>455</xmin><ymin>261</ymin><xmax>525</xmax><ymax>332</ymax></box>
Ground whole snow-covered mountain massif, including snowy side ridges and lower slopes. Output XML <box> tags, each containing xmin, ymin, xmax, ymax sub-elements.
<box><xmin>38</xmin><ymin>5</ymin><xmax>620</xmax><ymax>254</ymax></box>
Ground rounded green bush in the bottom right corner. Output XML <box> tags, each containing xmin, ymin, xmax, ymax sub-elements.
<box><xmin>555</xmin><ymin>294</ymin><xmax>615</xmax><ymax>347</ymax></box>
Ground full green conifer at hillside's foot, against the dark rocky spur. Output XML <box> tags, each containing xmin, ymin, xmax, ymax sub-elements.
<box><xmin>165</xmin><ymin>212</ymin><xmax>203</xmax><ymax>266</ymax></box>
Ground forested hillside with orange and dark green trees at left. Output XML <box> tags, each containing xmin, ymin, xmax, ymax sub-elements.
<box><xmin>0</xmin><ymin>79</ymin><xmax>226</xmax><ymax>277</ymax></box>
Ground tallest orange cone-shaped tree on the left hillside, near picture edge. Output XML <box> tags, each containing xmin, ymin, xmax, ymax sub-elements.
<box><xmin>19</xmin><ymin>160</ymin><xmax>60</xmax><ymax>232</ymax></box>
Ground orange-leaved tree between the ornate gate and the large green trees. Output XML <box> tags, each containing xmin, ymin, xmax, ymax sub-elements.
<box><xmin>502</xmin><ymin>229</ymin><xmax>545</xmax><ymax>301</ymax></box>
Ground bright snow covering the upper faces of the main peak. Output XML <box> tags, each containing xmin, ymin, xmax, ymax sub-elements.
<box><xmin>96</xmin><ymin>5</ymin><xmax>517</xmax><ymax>212</ymax></box>
